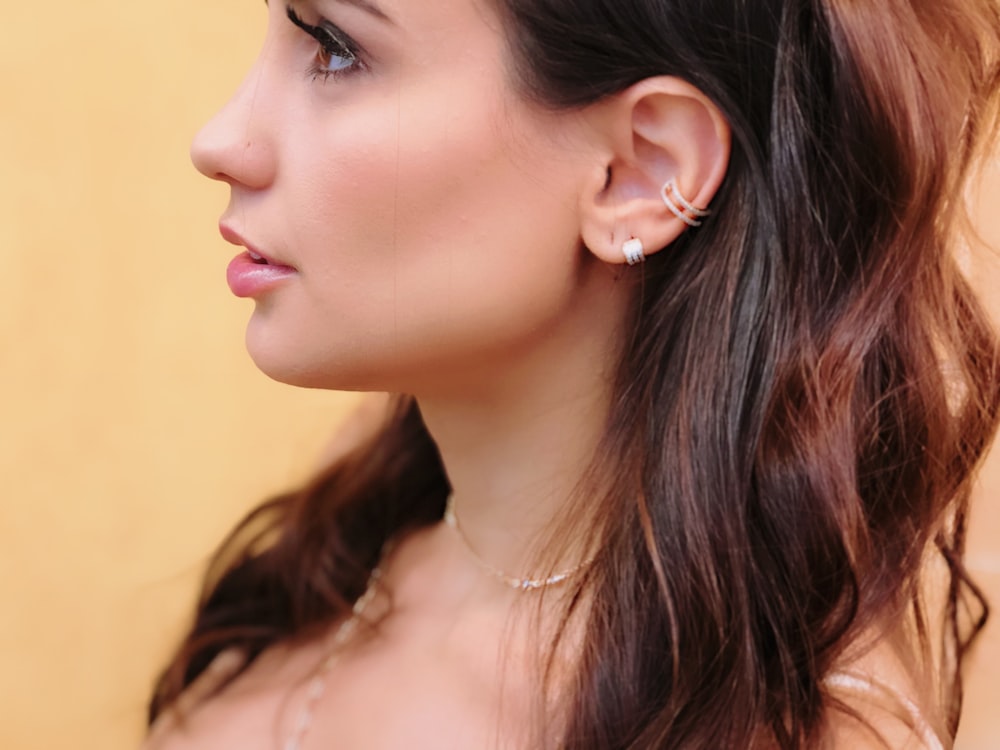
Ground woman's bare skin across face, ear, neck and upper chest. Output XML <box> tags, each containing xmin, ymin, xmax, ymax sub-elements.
<box><xmin>158</xmin><ymin>0</ymin><xmax>729</xmax><ymax>750</ymax></box>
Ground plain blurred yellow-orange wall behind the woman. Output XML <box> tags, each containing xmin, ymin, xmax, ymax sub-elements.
<box><xmin>0</xmin><ymin>0</ymin><xmax>1000</xmax><ymax>750</ymax></box>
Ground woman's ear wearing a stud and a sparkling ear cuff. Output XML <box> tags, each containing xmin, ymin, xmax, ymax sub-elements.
<box><xmin>580</xmin><ymin>76</ymin><xmax>730</xmax><ymax>263</ymax></box>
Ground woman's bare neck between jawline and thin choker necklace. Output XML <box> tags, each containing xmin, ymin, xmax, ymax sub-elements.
<box><xmin>418</xmin><ymin>324</ymin><xmax>611</xmax><ymax>578</ymax></box>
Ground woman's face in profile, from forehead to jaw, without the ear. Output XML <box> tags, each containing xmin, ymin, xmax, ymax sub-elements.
<box><xmin>192</xmin><ymin>0</ymin><xmax>608</xmax><ymax>392</ymax></box>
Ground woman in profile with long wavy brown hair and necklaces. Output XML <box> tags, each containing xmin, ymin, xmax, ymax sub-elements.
<box><xmin>148</xmin><ymin>0</ymin><xmax>1000</xmax><ymax>750</ymax></box>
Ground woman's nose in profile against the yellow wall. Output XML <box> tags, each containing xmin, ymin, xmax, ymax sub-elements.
<box><xmin>191</xmin><ymin>62</ymin><xmax>276</xmax><ymax>189</ymax></box>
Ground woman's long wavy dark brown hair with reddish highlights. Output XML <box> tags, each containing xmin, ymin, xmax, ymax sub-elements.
<box><xmin>150</xmin><ymin>0</ymin><xmax>1000</xmax><ymax>750</ymax></box>
